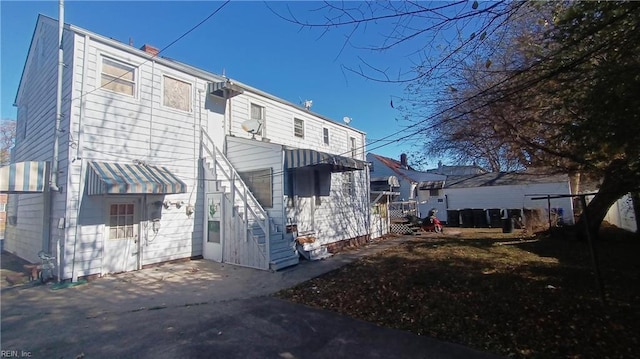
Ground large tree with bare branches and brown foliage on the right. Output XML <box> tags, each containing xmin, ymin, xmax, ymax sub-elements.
<box><xmin>272</xmin><ymin>1</ymin><xmax>640</xmax><ymax>238</ymax></box>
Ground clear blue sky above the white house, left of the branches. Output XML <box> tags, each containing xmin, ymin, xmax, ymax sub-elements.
<box><xmin>0</xmin><ymin>0</ymin><xmax>436</xmax><ymax>163</ymax></box>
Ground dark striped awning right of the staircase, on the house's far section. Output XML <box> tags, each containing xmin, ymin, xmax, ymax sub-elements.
<box><xmin>284</xmin><ymin>148</ymin><xmax>367</xmax><ymax>172</ymax></box>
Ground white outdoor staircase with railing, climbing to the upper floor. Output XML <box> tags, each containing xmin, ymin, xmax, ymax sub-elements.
<box><xmin>201</xmin><ymin>129</ymin><xmax>299</xmax><ymax>271</ymax></box>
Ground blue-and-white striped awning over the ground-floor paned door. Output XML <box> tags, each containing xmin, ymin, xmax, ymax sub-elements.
<box><xmin>87</xmin><ymin>162</ymin><xmax>187</xmax><ymax>195</ymax></box>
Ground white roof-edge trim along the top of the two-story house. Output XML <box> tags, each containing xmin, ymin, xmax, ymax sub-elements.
<box><xmin>14</xmin><ymin>14</ymin><xmax>366</xmax><ymax>135</ymax></box>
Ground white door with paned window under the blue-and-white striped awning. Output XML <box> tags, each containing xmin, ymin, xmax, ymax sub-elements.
<box><xmin>102</xmin><ymin>199</ymin><xmax>140</xmax><ymax>273</ymax></box>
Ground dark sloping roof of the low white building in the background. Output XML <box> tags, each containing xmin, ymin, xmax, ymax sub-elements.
<box><xmin>445</xmin><ymin>172</ymin><xmax>569</xmax><ymax>188</ymax></box>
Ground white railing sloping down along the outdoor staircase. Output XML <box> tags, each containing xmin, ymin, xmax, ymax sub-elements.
<box><xmin>200</xmin><ymin>127</ymin><xmax>270</xmax><ymax>266</ymax></box>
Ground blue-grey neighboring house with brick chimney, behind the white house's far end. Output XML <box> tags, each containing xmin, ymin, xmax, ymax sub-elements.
<box><xmin>367</xmin><ymin>153</ymin><xmax>446</xmax><ymax>220</ymax></box>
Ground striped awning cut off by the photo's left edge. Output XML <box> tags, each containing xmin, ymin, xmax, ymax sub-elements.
<box><xmin>0</xmin><ymin>161</ymin><xmax>49</xmax><ymax>193</ymax></box>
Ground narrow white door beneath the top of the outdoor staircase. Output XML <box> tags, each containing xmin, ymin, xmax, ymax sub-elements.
<box><xmin>203</xmin><ymin>193</ymin><xmax>225</xmax><ymax>262</ymax></box>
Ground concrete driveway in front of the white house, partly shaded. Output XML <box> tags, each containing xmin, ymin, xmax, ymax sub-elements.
<box><xmin>0</xmin><ymin>238</ymin><xmax>495</xmax><ymax>358</ymax></box>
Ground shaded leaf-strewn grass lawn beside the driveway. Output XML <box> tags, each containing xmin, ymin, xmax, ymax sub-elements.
<box><xmin>276</xmin><ymin>228</ymin><xmax>640</xmax><ymax>358</ymax></box>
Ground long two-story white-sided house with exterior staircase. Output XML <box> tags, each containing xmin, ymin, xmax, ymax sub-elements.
<box><xmin>5</xmin><ymin>15</ymin><xmax>370</xmax><ymax>280</ymax></box>
